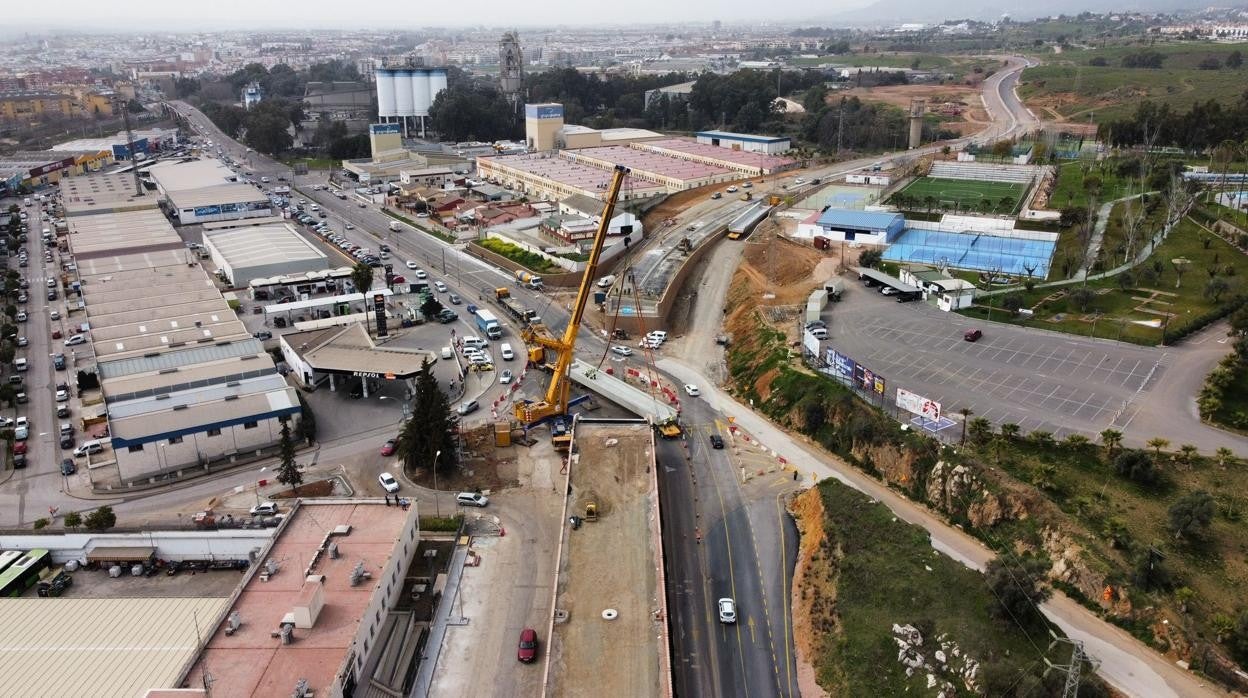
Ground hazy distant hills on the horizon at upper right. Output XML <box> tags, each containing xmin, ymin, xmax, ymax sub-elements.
<box><xmin>835</xmin><ymin>0</ymin><xmax>1209</xmax><ymax>24</ymax></box>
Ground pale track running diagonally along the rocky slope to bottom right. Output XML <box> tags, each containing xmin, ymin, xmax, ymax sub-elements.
<box><xmin>658</xmin><ymin>358</ymin><xmax>1223</xmax><ymax>698</ymax></box>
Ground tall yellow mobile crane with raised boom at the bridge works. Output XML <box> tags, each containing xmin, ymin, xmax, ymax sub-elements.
<box><xmin>514</xmin><ymin>165</ymin><xmax>628</xmax><ymax>426</ymax></box>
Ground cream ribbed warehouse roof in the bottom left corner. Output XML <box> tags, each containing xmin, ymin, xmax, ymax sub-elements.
<box><xmin>0</xmin><ymin>597</ymin><xmax>228</xmax><ymax>698</ymax></box>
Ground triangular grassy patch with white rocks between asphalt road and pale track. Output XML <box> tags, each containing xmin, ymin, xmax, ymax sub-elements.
<box><xmin>815</xmin><ymin>478</ymin><xmax>1045</xmax><ymax>696</ymax></box>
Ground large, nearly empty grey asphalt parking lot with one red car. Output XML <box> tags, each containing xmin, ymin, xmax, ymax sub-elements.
<box><xmin>824</xmin><ymin>283</ymin><xmax>1167</xmax><ymax>436</ymax></box>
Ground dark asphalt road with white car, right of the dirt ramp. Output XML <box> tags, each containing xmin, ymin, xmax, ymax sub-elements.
<box><xmin>658</xmin><ymin>400</ymin><xmax>797</xmax><ymax>696</ymax></box>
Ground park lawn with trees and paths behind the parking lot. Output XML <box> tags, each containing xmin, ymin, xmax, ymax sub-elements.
<box><xmin>960</xmin><ymin>220</ymin><xmax>1248</xmax><ymax>345</ymax></box>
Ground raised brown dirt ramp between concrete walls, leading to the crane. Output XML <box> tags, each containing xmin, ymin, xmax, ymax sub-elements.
<box><xmin>545</xmin><ymin>420</ymin><xmax>670</xmax><ymax>696</ymax></box>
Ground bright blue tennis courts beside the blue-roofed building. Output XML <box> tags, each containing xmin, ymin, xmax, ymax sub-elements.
<box><xmin>884</xmin><ymin>229</ymin><xmax>1057</xmax><ymax>278</ymax></box>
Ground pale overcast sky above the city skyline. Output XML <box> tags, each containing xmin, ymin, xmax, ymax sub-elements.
<box><xmin>4</xmin><ymin>0</ymin><xmax>870</xmax><ymax>31</ymax></box>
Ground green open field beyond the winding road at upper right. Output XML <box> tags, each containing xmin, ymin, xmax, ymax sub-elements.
<box><xmin>1018</xmin><ymin>42</ymin><xmax>1248</xmax><ymax>120</ymax></box>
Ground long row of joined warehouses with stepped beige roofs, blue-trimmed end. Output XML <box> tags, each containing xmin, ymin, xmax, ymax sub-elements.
<box><xmin>62</xmin><ymin>175</ymin><xmax>300</xmax><ymax>487</ymax></box>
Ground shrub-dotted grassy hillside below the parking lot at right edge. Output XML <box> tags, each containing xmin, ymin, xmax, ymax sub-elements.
<box><xmin>973</xmin><ymin>440</ymin><xmax>1248</xmax><ymax>654</ymax></box>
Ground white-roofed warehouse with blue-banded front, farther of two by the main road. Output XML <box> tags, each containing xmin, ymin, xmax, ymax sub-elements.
<box><xmin>149</xmin><ymin>160</ymin><xmax>273</xmax><ymax>225</ymax></box>
